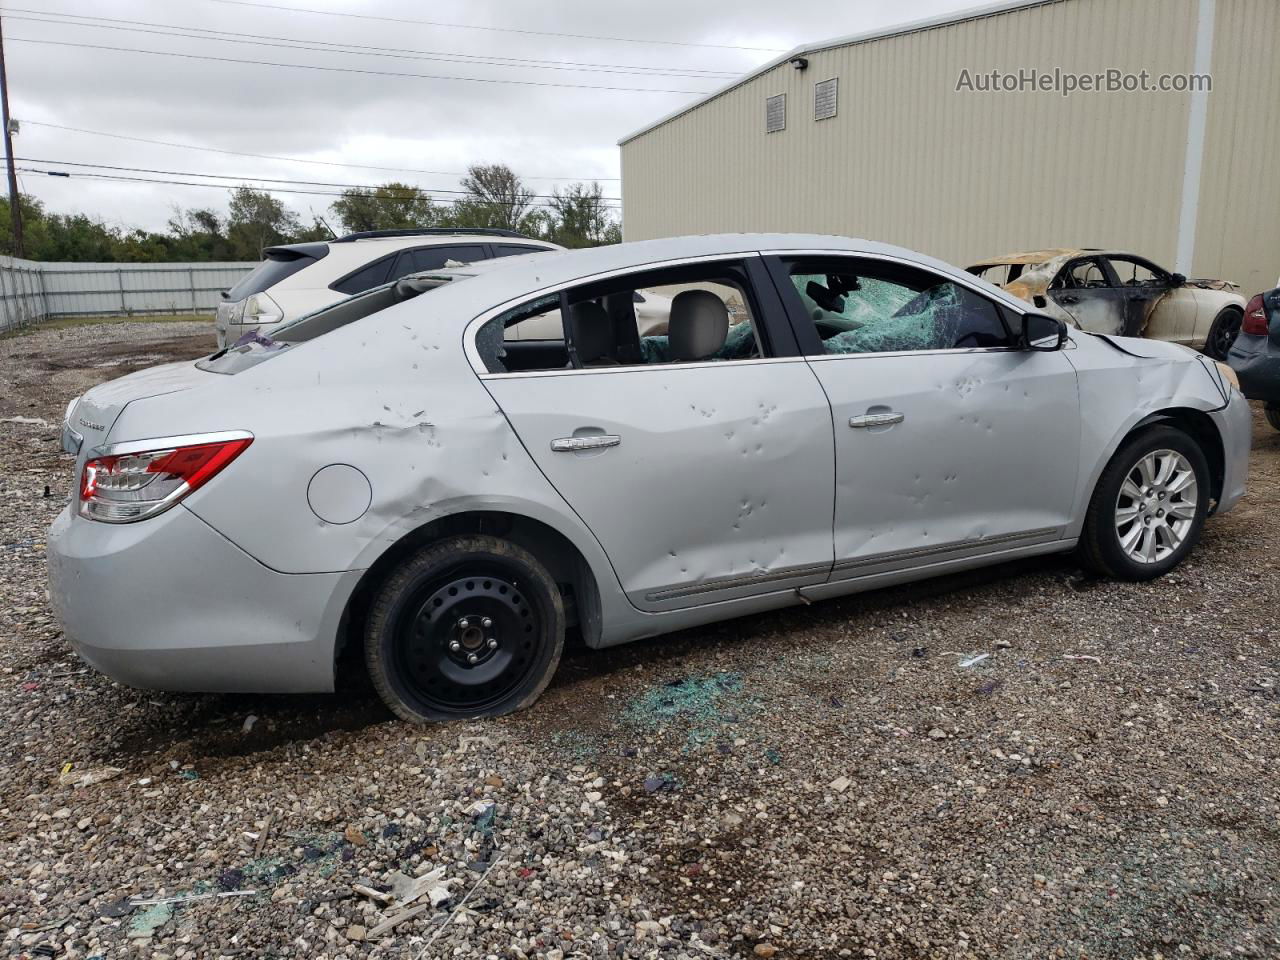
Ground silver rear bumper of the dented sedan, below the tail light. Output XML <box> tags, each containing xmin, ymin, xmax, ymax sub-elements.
<box><xmin>49</xmin><ymin>506</ymin><xmax>360</xmax><ymax>692</ymax></box>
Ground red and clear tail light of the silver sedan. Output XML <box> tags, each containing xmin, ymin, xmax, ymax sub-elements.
<box><xmin>79</xmin><ymin>434</ymin><xmax>253</xmax><ymax>524</ymax></box>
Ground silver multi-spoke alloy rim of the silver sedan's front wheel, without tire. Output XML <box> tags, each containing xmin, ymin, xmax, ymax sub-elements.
<box><xmin>1115</xmin><ymin>449</ymin><xmax>1199</xmax><ymax>563</ymax></box>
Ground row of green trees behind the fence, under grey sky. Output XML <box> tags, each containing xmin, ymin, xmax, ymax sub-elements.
<box><xmin>0</xmin><ymin>164</ymin><xmax>622</xmax><ymax>264</ymax></box>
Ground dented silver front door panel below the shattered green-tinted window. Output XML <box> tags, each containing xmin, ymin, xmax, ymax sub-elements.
<box><xmin>810</xmin><ymin>351</ymin><xmax>1079</xmax><ymax>580</ymax></box>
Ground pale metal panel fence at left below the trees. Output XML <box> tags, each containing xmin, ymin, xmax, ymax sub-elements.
<box><xmin>0</xmin><ymin>256</ymin><xmax>256</xmax><ymax>333</ymax></box>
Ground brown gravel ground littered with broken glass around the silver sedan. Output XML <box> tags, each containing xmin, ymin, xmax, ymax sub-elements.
<box><xmin>0</xmin><ymin>323</ymin><xmax>1280</xmax><ymax>960</ymax></box>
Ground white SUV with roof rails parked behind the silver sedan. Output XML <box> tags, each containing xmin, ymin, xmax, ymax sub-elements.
<box><xmin>214</xmin><ymin>228</ymin><xmax>562</xmax><ymax>347</ymax></box>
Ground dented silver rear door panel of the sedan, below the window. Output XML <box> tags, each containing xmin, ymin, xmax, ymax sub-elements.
<box><xmin>485</xmin><ymin>358</ymin><xmax>833</xmax><ymax>611</ymax></box>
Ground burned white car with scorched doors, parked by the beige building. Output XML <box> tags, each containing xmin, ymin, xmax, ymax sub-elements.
<box><xmin>969</xmin><ymin>250</ymin><xmax>1244</xmax><ymax>360</ymax></box>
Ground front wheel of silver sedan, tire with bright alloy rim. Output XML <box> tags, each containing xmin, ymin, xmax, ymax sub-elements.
<box><xmin>1079</xmin><ymin>425</ymin><xmax>1210</xmax><ymax>580</ymax></box>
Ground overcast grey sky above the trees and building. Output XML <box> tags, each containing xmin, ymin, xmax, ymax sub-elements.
<box><xmin>0</xmin><ymin>0</ymin><xmax>974</xmax><ymax>229</ymax></box>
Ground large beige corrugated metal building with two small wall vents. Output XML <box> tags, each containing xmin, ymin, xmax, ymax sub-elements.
<box><xmin>620</xmin><ymin>0</ymin><xmax>1280</xmax><ymax>292</ymax></box>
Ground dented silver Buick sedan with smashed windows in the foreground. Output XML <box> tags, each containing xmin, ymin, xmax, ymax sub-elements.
<box><xmin>49</xmin><ymin>234</ymin><xmax>1251</xmax><ymax>722</ymax></box>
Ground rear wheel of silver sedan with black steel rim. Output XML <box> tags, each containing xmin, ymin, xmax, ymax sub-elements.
<box><xmin>365</xmin><ymin>535</ymin><xmax>564</xmax><ymax>723</ymax></box>
